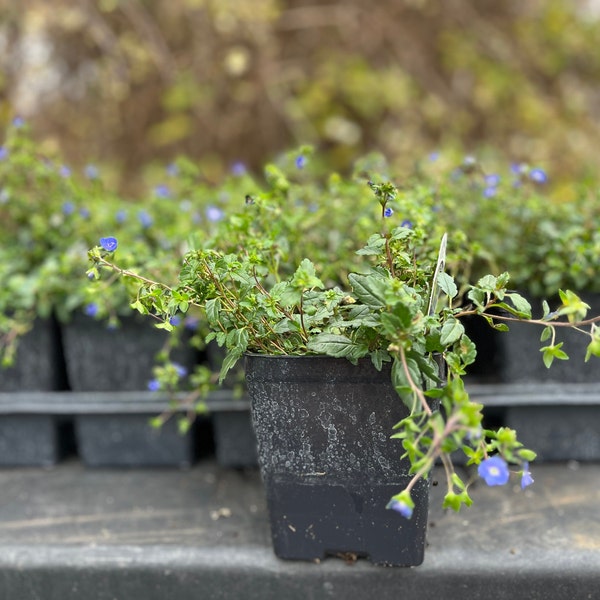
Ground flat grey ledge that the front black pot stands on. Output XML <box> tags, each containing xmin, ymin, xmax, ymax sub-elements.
<box><xmin>0</xmin><ymin>462</ymin><xmax>600</xmax><ymax>600</ymax></box>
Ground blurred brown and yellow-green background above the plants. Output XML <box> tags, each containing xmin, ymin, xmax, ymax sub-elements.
<box><xmin>0</xmin><ymin>0</ymin><xmax>600</xmax><ymax>196</ymax></box>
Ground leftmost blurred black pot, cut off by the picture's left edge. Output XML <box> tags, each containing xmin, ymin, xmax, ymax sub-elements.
<box><xmin>0</xmin><ymin>318</ymin><xmax>66</xmax><ymax>467</ymax></box>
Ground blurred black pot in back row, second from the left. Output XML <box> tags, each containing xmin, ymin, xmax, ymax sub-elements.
<box><xmin>63</xmin><ymin>315</ymin><xmax>197</xmax><ymax>467</ymax></box>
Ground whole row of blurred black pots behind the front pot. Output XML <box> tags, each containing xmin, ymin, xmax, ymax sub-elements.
<box><xmin>0</xmin><ymin>298</ymin><xmax>600</xmax><ymax>467</ymax></box>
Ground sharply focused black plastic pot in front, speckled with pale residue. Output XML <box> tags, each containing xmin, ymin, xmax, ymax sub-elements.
<box><xmin>246</xmin><ymin>355</ymin><xmax>429</xmax><ymax>566</ymax></box>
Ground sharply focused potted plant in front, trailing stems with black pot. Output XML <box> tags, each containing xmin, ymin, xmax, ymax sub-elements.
<box><xmin>89</xmin><ymin>175</ymin><xmax>600</xmax><ymax>565</ymax></box>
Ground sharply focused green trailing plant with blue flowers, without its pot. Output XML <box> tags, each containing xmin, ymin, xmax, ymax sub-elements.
<box><xmin>89</xmin><ymin>181</ymin><xmax>600</xmax><ymax>518</ymax></box>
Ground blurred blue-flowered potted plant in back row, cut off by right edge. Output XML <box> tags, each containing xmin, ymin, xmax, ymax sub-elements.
<box><xmin>421</xmin><ymin>157</ymin><xmax>600</xmax><ymax>460</ymax></box>
